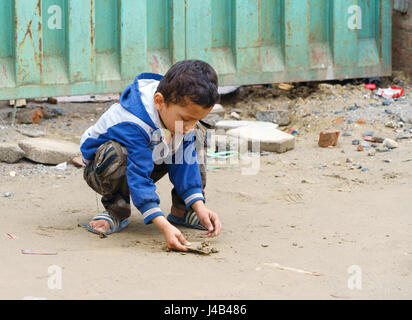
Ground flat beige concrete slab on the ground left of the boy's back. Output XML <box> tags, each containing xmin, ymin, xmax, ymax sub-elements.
<box><xmin>19</xmin><ymin>138</ymin><xmax>80</xmax><ymax>164</ymax></box>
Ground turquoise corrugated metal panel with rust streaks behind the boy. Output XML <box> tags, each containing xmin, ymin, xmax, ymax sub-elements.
<box><xmin>0</xmin><ymin>0</ymin><xmax>392</xmax><ymax>100</ymax></box>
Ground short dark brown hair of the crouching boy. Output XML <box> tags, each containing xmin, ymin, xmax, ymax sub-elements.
<box><xmin>157</xmin><ymin>60</ymin><xmax>219</xmax><ymax>108</ymax></box>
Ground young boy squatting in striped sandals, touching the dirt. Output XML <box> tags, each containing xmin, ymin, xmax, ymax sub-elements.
<box><xmin>80</xmin><ymin>60</ymin><xmax>221</xmax><ymax>251</ymax></box>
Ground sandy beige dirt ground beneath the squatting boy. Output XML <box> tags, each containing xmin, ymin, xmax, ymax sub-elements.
<box><xmin>0</xmin><ymin>78</ymin><xmax>412</xmax><ymax>299</ymax></box>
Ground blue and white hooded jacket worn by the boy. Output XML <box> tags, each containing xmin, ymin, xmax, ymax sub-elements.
<box><xmin>80</xmin><ymin>73</ymin><xmax>205</xmax><ymax>224</ymax></box>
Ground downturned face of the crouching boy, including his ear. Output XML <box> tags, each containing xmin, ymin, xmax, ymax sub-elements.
<box><xmin>154</xmin><ymin>92</ymin><xmax>213</xmax><ymax>135</ymax></box>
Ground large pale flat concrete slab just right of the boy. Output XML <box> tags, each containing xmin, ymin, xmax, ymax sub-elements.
<box><xmin>227</xmin><ymin>122</ymin><xmax>295</xmax><ymax>153</ymax></box>
